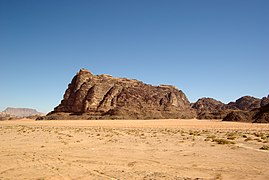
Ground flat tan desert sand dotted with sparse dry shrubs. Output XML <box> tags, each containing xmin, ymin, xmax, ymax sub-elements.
<box><xmin>0</xmin><ymin>119</ymin><xmax>269</xmax><ymax>180</ymax></box>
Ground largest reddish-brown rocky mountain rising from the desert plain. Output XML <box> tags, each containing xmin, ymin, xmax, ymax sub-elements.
<box><xmin>45</xmin><ymin>69</ymin><xmax>195</xmax><ymax>119</ymax></box>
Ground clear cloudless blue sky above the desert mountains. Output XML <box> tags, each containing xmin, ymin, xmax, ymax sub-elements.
<box><xmin>0</xmin><ymin>0</ymin><xmax>269</xmax><ymax>113</ymax></box>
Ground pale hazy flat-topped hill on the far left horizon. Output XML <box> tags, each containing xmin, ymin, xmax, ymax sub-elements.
<box><xmin>2</xmin><ymin>107</ymin><xmax>43</xmax><ymax>117</ymax></box>
